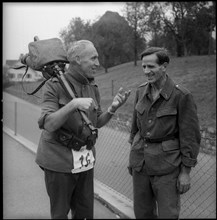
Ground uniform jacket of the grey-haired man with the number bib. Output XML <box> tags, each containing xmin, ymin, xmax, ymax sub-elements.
<box><xmin>36</xmin><ymin>66</ymin><xmax>102</xmax><ymax>172</ymax></box>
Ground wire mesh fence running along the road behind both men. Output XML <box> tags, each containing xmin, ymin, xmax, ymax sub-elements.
<box><xmin>3</xmin><ymin>91</ymin><xmax>216</xmax><ymax>218</ymax></box>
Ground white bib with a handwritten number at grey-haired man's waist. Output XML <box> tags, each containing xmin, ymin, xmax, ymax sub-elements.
<box><xmin>71</xmin><ymin>147</ymin><xmax>95</xmax><ymax>173</ymax></box>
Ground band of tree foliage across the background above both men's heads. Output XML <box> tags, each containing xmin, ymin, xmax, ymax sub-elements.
<box><xmin>60</xmin><ymin>1</ymin><xmax>216</xmax><ymax>72</ymax></box>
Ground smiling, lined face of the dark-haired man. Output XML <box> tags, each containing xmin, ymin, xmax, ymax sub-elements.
<box><xmin>142</xmin><ymin>54</ymin><xmax>167</xmax><ymax>83</ymax></box>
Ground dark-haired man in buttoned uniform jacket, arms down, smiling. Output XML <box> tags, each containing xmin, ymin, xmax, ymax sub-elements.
<box><xmin>128</xmin><ymin>47</ymin><xmax>201</xmax><ymax>219</ymax></box>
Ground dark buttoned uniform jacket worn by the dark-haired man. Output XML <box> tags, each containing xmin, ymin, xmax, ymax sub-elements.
<box><xmin>129</xmin><ymin>76</ymin><xmax>201</xmax><ymax>175</ymax></box>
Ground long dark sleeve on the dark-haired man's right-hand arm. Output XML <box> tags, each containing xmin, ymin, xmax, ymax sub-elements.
<box><xmin>178</xmin><ymin>93</ymin><xmax>201</xmax><ymax>167</ymax></box>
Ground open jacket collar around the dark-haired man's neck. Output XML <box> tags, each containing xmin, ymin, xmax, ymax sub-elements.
<box><xmin>144</xmin><ymin>75</ymin><xmax>175</xmax><ymax>100</ymax></box>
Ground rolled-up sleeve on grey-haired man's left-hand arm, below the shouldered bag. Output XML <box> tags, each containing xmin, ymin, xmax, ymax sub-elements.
<box><xmin>38</xmin><ymin>82</ymin><xmax>59</xmax><ymax>129</ymax></box>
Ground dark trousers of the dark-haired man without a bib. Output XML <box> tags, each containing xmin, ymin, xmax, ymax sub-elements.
<box><xmin>132</xmin><ymin>168</ymin><xmax>180</xmax><ymax>219</ymax></box>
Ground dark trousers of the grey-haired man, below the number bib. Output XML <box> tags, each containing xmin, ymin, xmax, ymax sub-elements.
<box><xmin>44</xmin><ymin>169</ymin><xmax>94</xmax><ymax>219</ymax></box>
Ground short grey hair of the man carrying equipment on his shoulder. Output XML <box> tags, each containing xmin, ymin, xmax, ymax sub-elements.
<box><xmin>67</xmin><ymin>40</ymin><xmax>94</xmax><ymax>62</ymax></box>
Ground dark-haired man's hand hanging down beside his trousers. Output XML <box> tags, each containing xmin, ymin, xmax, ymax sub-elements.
<box><xmin>177</xmin><ymin>165</ymin><xmax>191</xmax><ymax>194</ymax></box>
